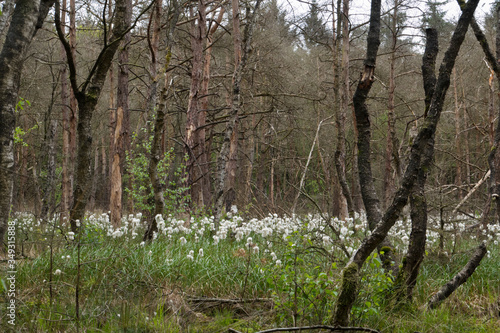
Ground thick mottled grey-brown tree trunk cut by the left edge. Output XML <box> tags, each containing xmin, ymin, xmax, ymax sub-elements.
<box><xmin>0</xmin><ymin>0</ymin><xmax>54</xmax><ymax>242</ymax></box>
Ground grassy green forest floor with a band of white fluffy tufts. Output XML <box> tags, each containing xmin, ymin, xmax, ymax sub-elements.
<box><xmin>0</xmin><ymin>214</ymin><xmax>500</xmax><ymax>333</ymax></box>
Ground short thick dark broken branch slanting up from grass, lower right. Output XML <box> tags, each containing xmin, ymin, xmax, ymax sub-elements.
<box><xmin>427</xmin><ymin>243</ymin><xmax>487</xmax><ymax>309</ymax></box>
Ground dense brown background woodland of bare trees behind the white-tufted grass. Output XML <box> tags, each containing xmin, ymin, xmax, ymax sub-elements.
<box><xmin>2</xmin><ymin>0</ymin><xmax>497</xmax><ymax>227</ymax></box>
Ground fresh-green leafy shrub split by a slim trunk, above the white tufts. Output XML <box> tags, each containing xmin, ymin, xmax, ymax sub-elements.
<box><xmin>125</xmin><ymin>122</ymin><xmax>189</xmax><ymax>215</ymax></box>
